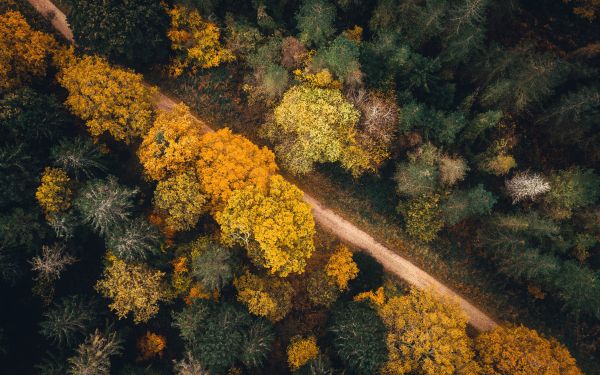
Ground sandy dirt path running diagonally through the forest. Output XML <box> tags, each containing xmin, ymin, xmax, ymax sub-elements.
<box><xmin>27</xmin><ymin>0</ymin><xmax>498</xmax><ymax>331</ymax></box>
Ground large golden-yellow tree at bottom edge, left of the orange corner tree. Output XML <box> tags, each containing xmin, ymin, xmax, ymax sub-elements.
<box><xmin>380</xmin><ymin>289</ymin><xmax>478</xmax><ymax>375</ymax></box>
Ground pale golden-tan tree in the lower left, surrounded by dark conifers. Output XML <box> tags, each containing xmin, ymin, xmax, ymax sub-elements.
<box><xmin>96</xmin><ymin>255</ymin><xmax>165</xmax><ymax>324</ymax></box>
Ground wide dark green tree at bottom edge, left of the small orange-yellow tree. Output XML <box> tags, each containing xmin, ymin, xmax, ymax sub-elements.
<box><xmin>173</xmin><ymin>300</ymin><xmax>273</xmax><ymax>373</ymax></box>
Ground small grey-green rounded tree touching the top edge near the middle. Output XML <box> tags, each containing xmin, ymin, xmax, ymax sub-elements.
<box><xmin>296</xmin><ymin>0</ymin><xmax>335</xmax><ymax>47</ymax></box>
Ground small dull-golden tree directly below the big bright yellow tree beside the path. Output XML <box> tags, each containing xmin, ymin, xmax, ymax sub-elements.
<box><xmin>233</xmin><ymin>271</ymin><xmax>294</xmax><ymax>322</ymax></box>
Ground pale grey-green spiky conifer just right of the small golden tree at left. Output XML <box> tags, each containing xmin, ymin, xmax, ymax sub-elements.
<box><xmin>74</xmin><ymin>176</ymin><xmax>138</xmax><ymax>236</ymax></box>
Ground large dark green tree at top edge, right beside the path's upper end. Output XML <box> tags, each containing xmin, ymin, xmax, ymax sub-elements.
<box><xmin>68</xmin><ymin>0</ymin><xmax>169</xmax><ymax>68</ymax></box>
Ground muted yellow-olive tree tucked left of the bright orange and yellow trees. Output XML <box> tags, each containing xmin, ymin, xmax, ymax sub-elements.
<box><xmin>154</xmin><ymin>172</ymin><xmax>206</xmax><ymax>231</ymax></box>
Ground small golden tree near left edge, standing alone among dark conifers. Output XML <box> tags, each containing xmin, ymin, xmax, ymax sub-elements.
<box><xmin>35</xmin><ymin>167</ymin><xmax>73</xmax><ymax>215</ymax></box>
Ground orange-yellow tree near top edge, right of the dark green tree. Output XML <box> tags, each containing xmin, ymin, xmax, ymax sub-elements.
<box><xmin>167</xmin><ymin>5</ymin><xmax>235</xmax><ymax>76</ymax></box>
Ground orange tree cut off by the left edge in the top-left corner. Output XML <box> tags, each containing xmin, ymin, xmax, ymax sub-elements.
<box><xmin>0</xmin><ymin>11</ymin><xmax>56</xmax><ymax>92</ymax></box>
